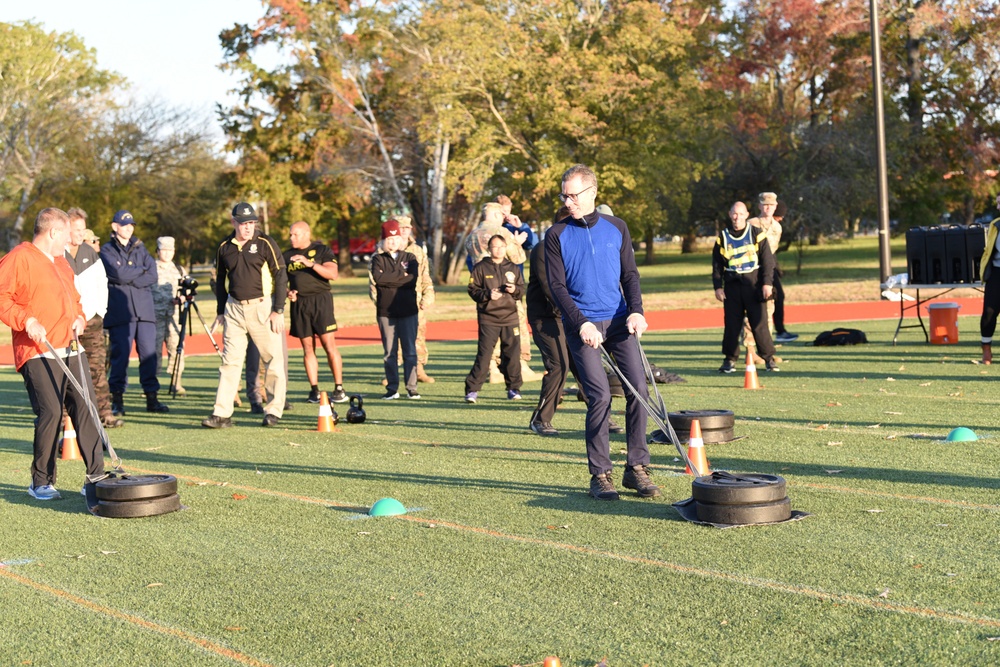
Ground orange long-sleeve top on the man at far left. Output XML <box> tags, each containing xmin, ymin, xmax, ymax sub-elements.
<box><xmin>0</xmin><ymin>241</ymin><xmax>83</xmax><ymax>370</ymax></box>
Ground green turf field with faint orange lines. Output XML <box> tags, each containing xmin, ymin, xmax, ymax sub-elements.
<box><xmin>0</xmin><ymin>318</ymin><xmax>1000</xmax><ymax>667</ymax></box>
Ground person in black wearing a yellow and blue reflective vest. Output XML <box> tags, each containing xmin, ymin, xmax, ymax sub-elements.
<box><xmin>712</xmin><ymin>201</ymin><xmax>778</xmax><ymax>373</ymax></box>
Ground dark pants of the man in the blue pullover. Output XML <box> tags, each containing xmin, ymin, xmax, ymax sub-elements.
<box><xmin>566</xmin><ymin>317</ymin><xmax>652</xmax><ymax>475</ymax></box>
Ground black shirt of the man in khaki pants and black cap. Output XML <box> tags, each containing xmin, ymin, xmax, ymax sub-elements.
<box><xmin>215</xmin><ymin>231</ymin><xmax>288</xmax><ymax>315</ymax></box>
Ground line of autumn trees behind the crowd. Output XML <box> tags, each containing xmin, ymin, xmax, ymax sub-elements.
<box><xmin>0</xmin><ymin>0</ymin><xmax>1000</xmax><ymax>282</ymax></box>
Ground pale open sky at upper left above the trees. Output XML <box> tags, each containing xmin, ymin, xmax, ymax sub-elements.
<box><xmin>0</xmin><ymin>0</ymin><xmax>280</xmax><ymax>126</ymax></box>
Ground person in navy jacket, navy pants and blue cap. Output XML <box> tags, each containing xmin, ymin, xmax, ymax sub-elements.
<box><xmin>101</xmin><ymin>210</ymin><xmax>170</xmax><ymax>415</ymax></box>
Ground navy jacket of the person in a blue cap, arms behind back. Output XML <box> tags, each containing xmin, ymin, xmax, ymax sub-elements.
<box><xmin>101</xmin><ymin>236</ymin><xmax>156</xmax><ymax>328</ymax></box>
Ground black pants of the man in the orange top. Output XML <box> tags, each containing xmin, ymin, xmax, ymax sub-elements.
<box><xmin>21</xmin><ymin>354</ymin><xmax>104</xmax><ymax>487</ymax></box>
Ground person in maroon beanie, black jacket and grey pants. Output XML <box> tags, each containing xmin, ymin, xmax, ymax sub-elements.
<box><xmin>371</xmin><ymin>219</ymin><xmax>420</xmax><ymax>401</ymax></box>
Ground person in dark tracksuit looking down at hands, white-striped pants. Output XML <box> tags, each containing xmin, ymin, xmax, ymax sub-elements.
<box><xmin>465</xmin><ymin>234</ymin><xmax>524</xmax><ymax>403</ymax></box>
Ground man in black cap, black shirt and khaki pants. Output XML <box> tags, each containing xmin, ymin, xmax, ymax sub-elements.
<box><xmin>201</xmin><ymin>202</ymin><xmax>288</xmax><ymax>428</ymax></box>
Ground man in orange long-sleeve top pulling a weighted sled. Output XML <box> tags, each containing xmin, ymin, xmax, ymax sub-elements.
<box><xmin>0</xmin><ymin>208</ymin><xmax>104</xmax><ymax>500</ymax></box>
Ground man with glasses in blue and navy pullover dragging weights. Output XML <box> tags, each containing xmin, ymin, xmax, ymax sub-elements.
<box><xmin>545</xmin><ymin>164</ymin><xmax>660</xmax><ymax>500</ymax></box>
